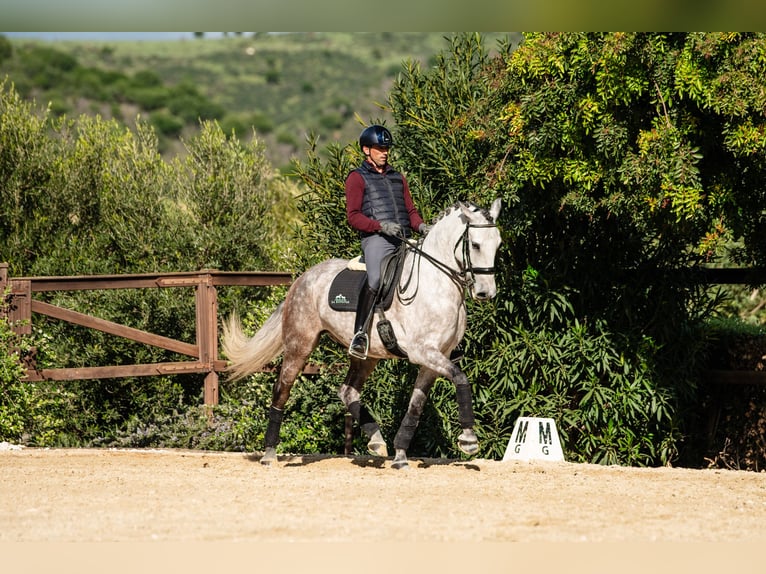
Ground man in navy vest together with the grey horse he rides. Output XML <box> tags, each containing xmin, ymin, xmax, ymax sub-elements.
<box><xmin>222</xmin><ymin>126</ymin><xmax>502</xmax><ymax>469</ymax></box>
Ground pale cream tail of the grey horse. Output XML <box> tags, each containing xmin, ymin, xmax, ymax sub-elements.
<box><xmin>221</xmin><ymin>301</ymin><xmax>284</xmax><ymax>380</ymax></box>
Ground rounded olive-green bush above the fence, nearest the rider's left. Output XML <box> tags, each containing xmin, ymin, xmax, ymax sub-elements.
<box><xmin>173</xmin><ymin>122</ymin><xmax>298</xmax><ymax>271</ymax></box>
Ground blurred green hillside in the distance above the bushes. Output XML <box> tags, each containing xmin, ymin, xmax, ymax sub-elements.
<box><xmin>0</xmin><ymin>32</ymin><xmax>520</xmax><ymax>170</ymax></box>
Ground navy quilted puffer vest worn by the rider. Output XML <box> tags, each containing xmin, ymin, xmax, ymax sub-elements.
<box><xmin>355</xmin><ymin>162</ymin><xmax>411</xmax><ymax>237</ymax></box>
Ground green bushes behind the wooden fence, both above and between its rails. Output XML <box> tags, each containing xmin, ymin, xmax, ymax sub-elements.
<box><xmin>0</xmin><ymin>80</ymin><xmax>296</xmax><ymax>446</ymax></box>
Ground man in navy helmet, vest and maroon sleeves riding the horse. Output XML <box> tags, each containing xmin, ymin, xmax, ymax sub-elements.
<box><xmin>346</xmin><ymin>125</ymin><xmax>428</xmax><ymax>359</ymax></box>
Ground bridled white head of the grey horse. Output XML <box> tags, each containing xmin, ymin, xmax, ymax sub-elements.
<box><xmin>455</xmin><ymin>198</ymin><xmax>502</xmax><ymax>301</ymax></box>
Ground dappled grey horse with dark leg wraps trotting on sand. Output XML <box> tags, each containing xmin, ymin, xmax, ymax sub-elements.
<box><xmin>222</xmin><ymin>198</ymin><xmax>501</xmax><ymax>469</ymax></box>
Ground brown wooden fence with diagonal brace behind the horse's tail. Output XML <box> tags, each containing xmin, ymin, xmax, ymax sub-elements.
<box><xmin>0</xmin><ymin>263</ymin><xmax>296</xmax><ymax>406</ymax></box>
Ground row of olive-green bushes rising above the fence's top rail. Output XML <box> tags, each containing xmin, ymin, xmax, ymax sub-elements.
<box><xmin>0</xmin><ymin>81</ymin><xmax>296</xmax><ymax>275</ymax></box>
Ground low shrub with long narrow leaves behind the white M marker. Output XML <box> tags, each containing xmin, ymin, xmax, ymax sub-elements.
<box><xmin>466</xmin><ymin>270</ymin><xmax>677</xmax><ymax>465</ymax></box>
